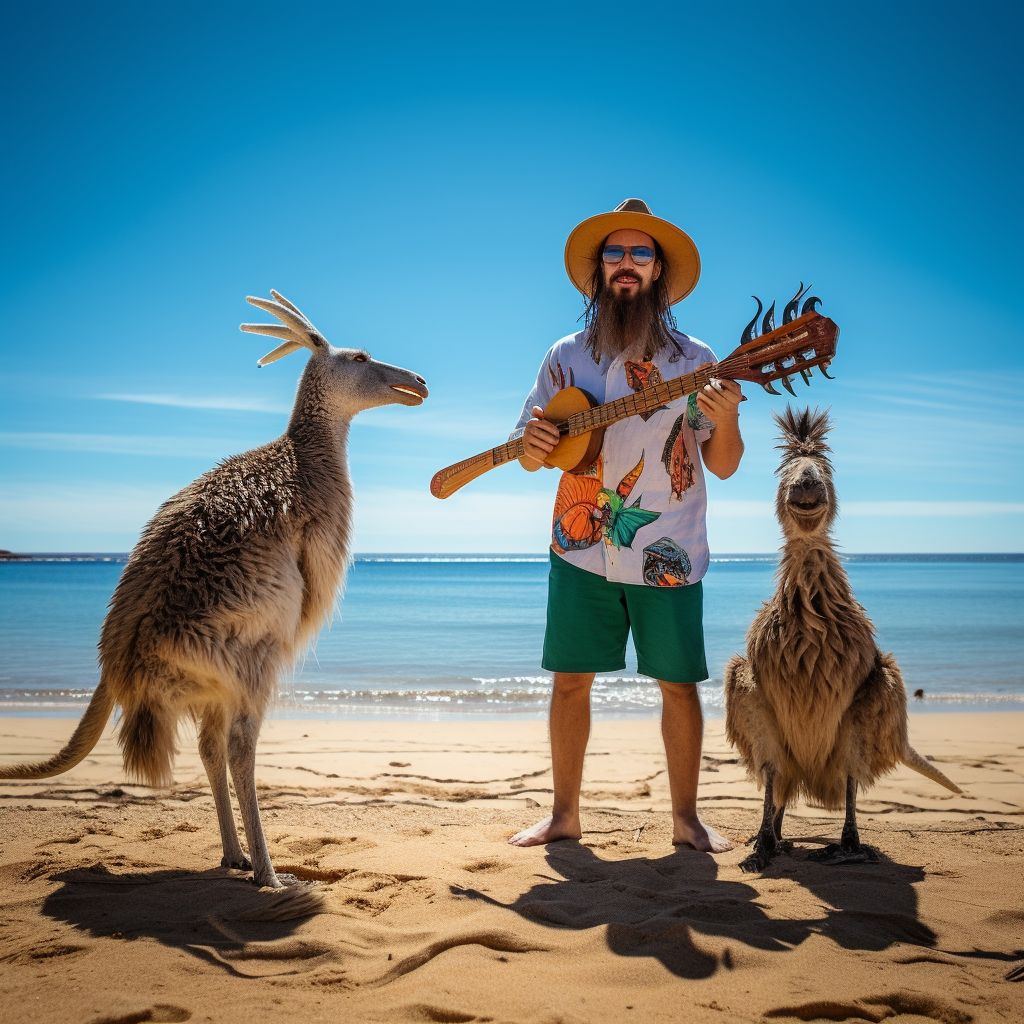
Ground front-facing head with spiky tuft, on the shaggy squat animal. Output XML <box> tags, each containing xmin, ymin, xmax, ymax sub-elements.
<box><xmin>772</xmin><ymin>406</ymin><xmax>839</xmax><ymax>540</ymax></box>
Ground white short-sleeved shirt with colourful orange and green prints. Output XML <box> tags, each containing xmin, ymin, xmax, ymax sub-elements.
<box><xmin>512</xmin><ymin>331</ymin><xmax>717</xmax><ymax>587</ymax></box>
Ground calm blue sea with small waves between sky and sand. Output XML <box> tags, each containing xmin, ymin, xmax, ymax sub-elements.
<box><xmin>0</xmin><ymin>553</ymin><xmax>1024</xmax><ymax>720</ymax></box>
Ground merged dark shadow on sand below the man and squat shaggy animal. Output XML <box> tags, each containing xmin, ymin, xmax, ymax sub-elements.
<box><xmin>452</xmin><ymin>841</ymin><xmax>936</xmax><ymax>978</ymax></box>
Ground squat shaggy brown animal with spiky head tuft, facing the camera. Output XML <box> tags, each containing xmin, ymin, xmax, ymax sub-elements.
<box><xmin>725</xmin><ymin>407</ymin><xmax>962</xmax><ymax>871</ymax></box>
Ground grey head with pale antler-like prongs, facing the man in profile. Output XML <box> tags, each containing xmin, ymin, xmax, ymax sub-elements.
<box><xmin>241</xmin><ymin>288</ymin><xmax>427</xmax><ymax>419</ymax></box>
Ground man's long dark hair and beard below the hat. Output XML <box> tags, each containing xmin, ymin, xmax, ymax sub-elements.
<box><xmin>581</xmin><ymin>242</ymin><xmax>678</xmax><ymax>364</ymax></box>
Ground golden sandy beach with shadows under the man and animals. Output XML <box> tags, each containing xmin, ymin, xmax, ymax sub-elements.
<box><xmin>0</xmin><ymin>714</ymin><xmax>1024</xmax><ymax>1024</ymax></box>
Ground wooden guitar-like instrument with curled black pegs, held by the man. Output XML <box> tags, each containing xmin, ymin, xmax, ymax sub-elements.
<box><xmin>430</xmin><ymin>284</ymin><xmax>839</xmax><ymax>498</ymax></box>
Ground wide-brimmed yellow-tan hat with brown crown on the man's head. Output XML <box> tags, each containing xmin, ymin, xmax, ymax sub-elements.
<box><xmin>565</xmin><ymin>199</ymin><xmax>700</xmax><ymax>305</ymax></box>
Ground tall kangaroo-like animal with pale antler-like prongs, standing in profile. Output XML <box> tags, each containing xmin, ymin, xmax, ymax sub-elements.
<box><xmin>0</xmin><ymin>290</ymin><xmax>427</xmax><ymax>888</ymax></box>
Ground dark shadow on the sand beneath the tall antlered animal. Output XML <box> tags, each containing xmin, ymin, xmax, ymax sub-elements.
<box><xmin>42</xmin><ymin>864</ymin><xmax>324</xmax><ymax>974</ymax></box>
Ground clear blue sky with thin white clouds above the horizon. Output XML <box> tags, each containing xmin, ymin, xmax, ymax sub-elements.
<box><xmin>0</xmin><ymin>2</ymin><xmax>1024</xmax><ymax>553</ymax></box>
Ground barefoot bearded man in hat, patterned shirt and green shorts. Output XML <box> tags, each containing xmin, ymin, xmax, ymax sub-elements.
<box><xmin>509</xmin><ymin>199</ymin><xmax>743</xmax><ymax>853</ymax></box>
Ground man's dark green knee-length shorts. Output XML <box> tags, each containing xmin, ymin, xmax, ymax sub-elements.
<box><xmin>541</xmin><ymin>552</ymin><xmax>708</xmax><ymax>683</ymax></box>
